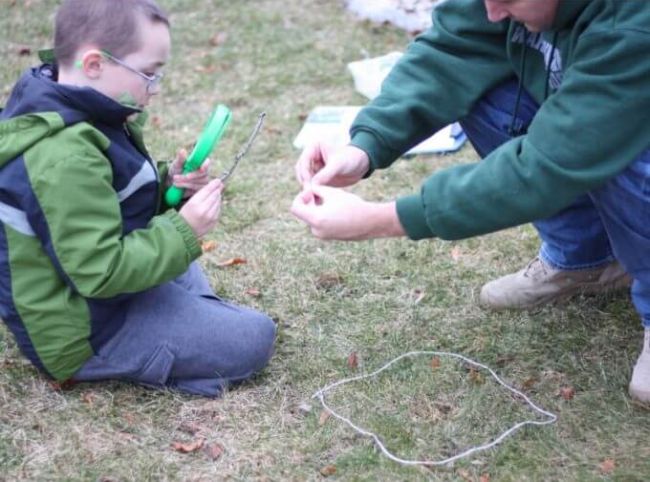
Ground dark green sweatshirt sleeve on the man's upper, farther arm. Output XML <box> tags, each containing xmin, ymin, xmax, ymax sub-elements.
<box><xmin>350</xmin><ymin>0</ymin><xmax>513</xmax><ymax>169</ymax></box>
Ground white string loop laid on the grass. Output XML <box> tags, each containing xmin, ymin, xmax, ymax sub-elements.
<box><xmin>312</xmin><ymin>351</ymin><xmax>557</xmax><ymax>466</ymax></box>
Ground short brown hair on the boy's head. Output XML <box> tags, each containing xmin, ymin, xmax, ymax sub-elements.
<box><xmin>54</xmin><ymin>0</ymin><xmax>169</xmax><ymax>67</ymax></box>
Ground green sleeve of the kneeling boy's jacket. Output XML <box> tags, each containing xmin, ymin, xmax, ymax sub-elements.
<box><xmin>28</xmin><ymin>130</ymin><xmax>201</xmax><ymax>298</ymax></box>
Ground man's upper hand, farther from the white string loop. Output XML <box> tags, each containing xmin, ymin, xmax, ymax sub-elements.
<box><xmin>296</xmin><ymin>142</ymin><xmax>370</xmax><ymax>187</ymax></box>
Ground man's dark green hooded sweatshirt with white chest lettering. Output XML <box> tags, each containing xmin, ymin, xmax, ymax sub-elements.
<box><xmin>350</xmin><ymin>0</ymin><xmax>650</xmax><ymax>239</ymax></box>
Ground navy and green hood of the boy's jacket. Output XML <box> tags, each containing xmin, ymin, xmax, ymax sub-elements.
<box><xmin>0</xmin><ymin>64</ymin><xmax>140</xmax><ymax>167</ymax></box>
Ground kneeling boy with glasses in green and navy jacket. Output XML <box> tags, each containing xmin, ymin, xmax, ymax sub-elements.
<box><xmin>0</xmin><ymin>0</ymin><xmax>275</xmax><ymax>396</ymax></box>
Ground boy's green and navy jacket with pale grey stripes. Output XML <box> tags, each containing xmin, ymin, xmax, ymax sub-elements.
<box><xmin>0</xmin><ymin>65</ymin><xmax>201</xmax><ymax>380</ymax></box>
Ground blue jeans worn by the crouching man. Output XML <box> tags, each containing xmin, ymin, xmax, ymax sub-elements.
<box><xmin>460</xmin><ymin>79</ymin><xmax>650</xmax><ymax>327</ymax></box>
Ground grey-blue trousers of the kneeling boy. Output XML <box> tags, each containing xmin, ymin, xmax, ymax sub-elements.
<box><xmin>72</xmin><ymin>263</ymin><xmax>275</xmax><ymax>397</ymax></box>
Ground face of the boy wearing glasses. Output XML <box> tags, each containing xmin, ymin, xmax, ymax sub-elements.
<box><xmin>88</xmin><ymin>18</ymin><xmax>171</xmax><ymax>108</ymax></box>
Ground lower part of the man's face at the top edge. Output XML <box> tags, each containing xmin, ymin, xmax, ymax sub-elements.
<box><xmin>485</xmin><ymin>0</ymin><xmax>560</xmax><ymax>32</ymax></box>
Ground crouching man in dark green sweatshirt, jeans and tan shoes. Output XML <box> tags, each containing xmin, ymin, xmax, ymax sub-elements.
<box><xmin>292</xmin><ymin>0</ymin><xmax>650</xmax><ymax>401</ymax></box>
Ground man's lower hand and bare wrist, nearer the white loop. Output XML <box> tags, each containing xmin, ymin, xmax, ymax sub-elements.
<box><xmin>291</xmin><ymin>185</ymin><xmax>405</xmax><ymax>241</ymax></box>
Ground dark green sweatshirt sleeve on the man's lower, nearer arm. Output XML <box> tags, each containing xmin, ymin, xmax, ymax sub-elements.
<box><xmin>397</xmin><ymin>29</ymin><xmax>650</xmax><ymax>239</ymax></box>
